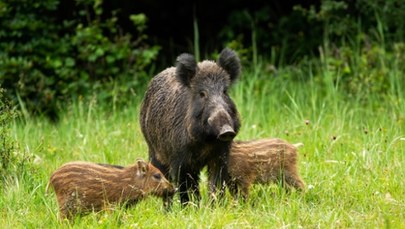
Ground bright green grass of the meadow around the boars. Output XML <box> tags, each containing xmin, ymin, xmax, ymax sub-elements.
<box><xmin>0</xmin><ymin>64</ymin><xmax>405</xmax><ymax>228</ymax></box>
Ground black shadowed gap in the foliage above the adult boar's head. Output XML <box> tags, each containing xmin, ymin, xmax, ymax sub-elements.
<box><xmin>105</xmin><ymin>0</ymin><xmax>319</xmax><ymax>63</ymax></box>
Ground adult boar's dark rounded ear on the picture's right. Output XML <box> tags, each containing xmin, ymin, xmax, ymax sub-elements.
<box><xmin>218</xmin><ymin>48</ymin><xmax>241</xmax><ymax>82</ymax></box>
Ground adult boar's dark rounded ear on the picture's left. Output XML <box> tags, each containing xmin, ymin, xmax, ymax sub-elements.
<box><xmin>176</xmin><ymin>53</ymin><xmax>197</xmax><ymax>86</ymax></box>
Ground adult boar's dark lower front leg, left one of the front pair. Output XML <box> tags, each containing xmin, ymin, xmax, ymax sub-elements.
<box><xmin>179</xmin><ymin>170</ymin><xmax>201</xmax><ymax>205</ymax></box>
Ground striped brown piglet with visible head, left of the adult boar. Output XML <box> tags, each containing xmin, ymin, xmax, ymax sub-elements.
<box><xmin>46</xmin><ymin>160</ymin><xmax>175</xmax><ymax>219</ymax></box>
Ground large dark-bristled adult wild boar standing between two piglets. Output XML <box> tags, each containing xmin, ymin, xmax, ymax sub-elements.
<box><xmin>140</xmin><ymin>49</ymin><xmax>241</xmax><ymax>204</ymax></box>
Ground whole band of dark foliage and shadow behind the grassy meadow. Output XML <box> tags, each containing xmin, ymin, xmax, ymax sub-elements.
<box><xmin>0</xmin><ymin>0</ymin><xmax>405</xmax><ymax>120</ymax></box>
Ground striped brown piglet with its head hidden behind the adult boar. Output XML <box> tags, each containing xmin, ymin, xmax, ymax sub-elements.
<box><xmin>223</xmin><ymin>138</ymin><xmax>305</xmax><ymax>199</ymax></box>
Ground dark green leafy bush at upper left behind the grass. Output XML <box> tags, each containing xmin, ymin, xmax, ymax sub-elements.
<box><xmin>0</xmin><ymin>0</ymin><xmax>159</xmax><ymax>118</ymax></box>
